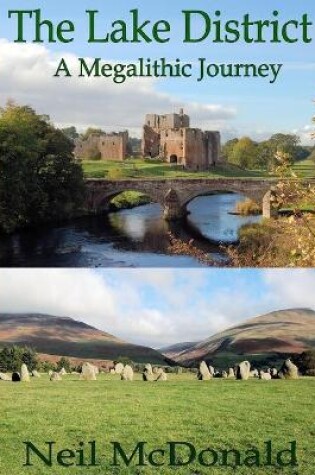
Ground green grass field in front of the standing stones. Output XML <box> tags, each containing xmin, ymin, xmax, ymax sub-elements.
<box><xmin>0</xmin><ymin>374</ymin><xmax>315</xmax><ymax>475</ymax></box>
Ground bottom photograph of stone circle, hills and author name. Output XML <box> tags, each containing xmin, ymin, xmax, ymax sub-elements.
<box><xmin>0</xmin><ymin>269</ymin><xmax>315</xmax><ymax>475</ymax></box>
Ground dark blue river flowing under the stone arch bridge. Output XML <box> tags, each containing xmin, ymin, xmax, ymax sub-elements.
<box><xmin>0</xmin><ymin>193</ymin><xmax>260</xmax><ymax>267</ymax></box>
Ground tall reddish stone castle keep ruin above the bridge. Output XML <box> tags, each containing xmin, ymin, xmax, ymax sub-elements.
<box><xmin>142</xmin><ymin>109</ymin><xmax>220</xmax><ymax>171</ymax></box>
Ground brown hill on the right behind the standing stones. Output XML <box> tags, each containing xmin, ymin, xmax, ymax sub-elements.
<box><xmin>163</xmin><ymin>309</ymin><xmax>315</xmax><ymax>366</ymax></box>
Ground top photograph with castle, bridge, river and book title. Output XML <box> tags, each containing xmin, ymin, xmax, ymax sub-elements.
<box><xmin>0</xmin><ymin>0</ymin><xmax>315</xmax><ymax>268</ymax></box>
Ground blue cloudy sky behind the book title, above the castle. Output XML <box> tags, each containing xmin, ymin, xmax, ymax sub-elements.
<box><xmin>0</xmin><ymin>0</ymin><xmax>315</xmax><ymax>142</ymax></box>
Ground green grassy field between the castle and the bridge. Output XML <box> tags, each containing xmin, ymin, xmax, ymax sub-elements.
<box><xmin>82</xmin><ymin>159</ymin><xmax>315</xmax><ymax>179</ymax></box>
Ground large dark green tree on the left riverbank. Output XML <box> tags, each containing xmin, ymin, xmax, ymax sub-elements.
<box><xmin>0</xmin><ymin>103</ymin><xmax>84</xmax><ymax>232</ymax></box>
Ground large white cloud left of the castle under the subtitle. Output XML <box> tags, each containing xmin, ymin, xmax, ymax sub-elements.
<box><xmin>0</xmin><ymin>39</ymin><xmax>236</xmax><ymax>132</ymax></box>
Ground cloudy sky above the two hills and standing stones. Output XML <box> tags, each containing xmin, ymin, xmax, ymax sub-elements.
<box><xmin>0</xmin><ymin>269</ymin><xmax>315</xmax><ymax>347</ymax></box>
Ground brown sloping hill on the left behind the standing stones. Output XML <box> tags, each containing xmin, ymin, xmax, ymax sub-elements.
<box><xmin>0</xmin><ymin>313</ymin><xmax>170</xmax><ymax>365</ymax></box>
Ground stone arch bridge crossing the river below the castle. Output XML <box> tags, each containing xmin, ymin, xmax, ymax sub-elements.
<box><xmin>86</xmin><ymin>178</ymin><xmax>276</xmax><ymax>220</ymax></box>
